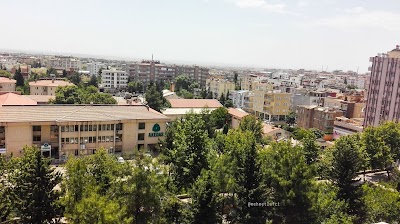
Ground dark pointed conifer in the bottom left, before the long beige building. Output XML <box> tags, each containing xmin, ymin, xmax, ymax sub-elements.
<box><xmin>12</xmin><ymin>146</ymin><xmax>61</xmax><ymax>223</ymax></box>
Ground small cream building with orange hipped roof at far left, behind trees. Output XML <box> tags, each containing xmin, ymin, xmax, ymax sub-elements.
<box><xmin>29</xmin><ymin>79</ymin><xmax>74</xmax><ymax>96</ymax></box>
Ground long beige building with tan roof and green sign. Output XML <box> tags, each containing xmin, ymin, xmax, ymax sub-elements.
<box><xmin>0</xmin><ymin>105</ymin><xmax>168</xmax><ymax>160</ymax></box>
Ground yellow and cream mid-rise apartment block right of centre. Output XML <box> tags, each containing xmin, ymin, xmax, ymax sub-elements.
<box><xmin>253</xmin><ymin>90</ymin><xmax>291</xmax><ymax>122</ymax></box>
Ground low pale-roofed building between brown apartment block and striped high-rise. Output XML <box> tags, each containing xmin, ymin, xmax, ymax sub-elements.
<box><xmin>333</xmin><ymin>117</ymin><xmax>364</xmax><ymax>139</ymax></box>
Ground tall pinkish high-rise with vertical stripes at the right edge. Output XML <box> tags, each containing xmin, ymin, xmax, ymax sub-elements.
<box><xmin>364</xmin><ymin>45</ymin><xmax>400</xmax><ymax>127</ymax></box>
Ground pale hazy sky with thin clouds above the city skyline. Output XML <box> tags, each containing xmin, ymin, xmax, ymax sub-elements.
<box><xmin>0</xmin><ymin>0</ymin><xmax>400</xmax><ymax>72</ymax></box>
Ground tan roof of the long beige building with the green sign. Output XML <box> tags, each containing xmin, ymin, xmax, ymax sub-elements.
<box><xmin>0</xmin><ymin>105</ymin><xmax>168</xmax><ymax>123</ymax></box>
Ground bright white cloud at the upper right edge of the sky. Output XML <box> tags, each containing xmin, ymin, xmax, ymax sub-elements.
<box><xmin>314</xmin><ymin>7</ymin><xmax>400</xmax><ymax>31</ymax></box>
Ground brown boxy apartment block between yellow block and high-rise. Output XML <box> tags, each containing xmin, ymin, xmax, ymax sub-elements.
<box><xmin>297</xmin><ymin>105</ymin><xmax>344</xmax><ymax>133</ymax></box>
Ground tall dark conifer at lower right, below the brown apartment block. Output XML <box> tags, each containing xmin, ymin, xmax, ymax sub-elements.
<box><xmin>330</xmin><ymin>135</ymin><xmax>364</xmax><ymax>220</ymax></box>
